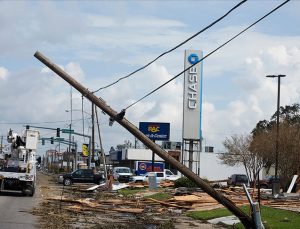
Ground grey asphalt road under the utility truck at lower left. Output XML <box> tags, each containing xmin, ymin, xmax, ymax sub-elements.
<box><xmin>0</xmin><ymin>174</ymin><xmax>40</xmax><ymax>229</ymax></box>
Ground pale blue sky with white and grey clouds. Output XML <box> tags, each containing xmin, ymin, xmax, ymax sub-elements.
<box><xmin>0</xmin><ymin>0</ymin><xmax>300</xmax><ymax>153</ymax></box>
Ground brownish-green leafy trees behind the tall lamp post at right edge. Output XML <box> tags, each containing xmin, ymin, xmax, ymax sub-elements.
<box><xmin>251</xmin><ymin>104</ymin><xmax>300</xmax><ymax>186</ymax></box>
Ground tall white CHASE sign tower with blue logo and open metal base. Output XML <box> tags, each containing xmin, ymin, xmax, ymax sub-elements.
<box><xmin>182</xmin><ymin>50</ymin><xmax>203</xmax><ymax>175</ymax></box>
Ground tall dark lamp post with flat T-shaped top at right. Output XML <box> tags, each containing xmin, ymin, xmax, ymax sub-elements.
<box><xmin>266</xmin><ymin>75</ymin><xmax>285</xmax><ymax>195</ymax></box>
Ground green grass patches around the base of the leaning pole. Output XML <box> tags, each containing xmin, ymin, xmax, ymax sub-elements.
<box><xmin>187</xmin><ymin>206</ymin><xmax>300</xmax><ymax>229</ymax></box>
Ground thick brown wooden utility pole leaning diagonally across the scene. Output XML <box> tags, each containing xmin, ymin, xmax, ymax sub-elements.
<box><xmin>34</xmin><ymin>52</ymin><xmax>255</xmax><ymax>228</ymax></box>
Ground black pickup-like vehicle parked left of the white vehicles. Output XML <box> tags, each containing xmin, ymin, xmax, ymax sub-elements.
<box><xmin>63</xmin><ymin>169</ymin><xmax>105</xmax><ymax>186</ymax></box>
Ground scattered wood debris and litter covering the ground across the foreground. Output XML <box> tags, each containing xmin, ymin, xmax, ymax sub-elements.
<box><xmin>34</xmin><ymin>173</ymin><xmax>300</xmax><ymax>229</ymax></box>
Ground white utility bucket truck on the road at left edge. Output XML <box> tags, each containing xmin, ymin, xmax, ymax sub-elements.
<box><xmin>0</xmin><ymin>129</ymin><xmax>39</xmax><ymax>196</ymax></box>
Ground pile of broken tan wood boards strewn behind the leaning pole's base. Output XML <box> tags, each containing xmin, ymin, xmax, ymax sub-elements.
<box><xmin>48</xmin><ymin>181</ymin><xmax>300</xmax><ymax>214</ymax></box>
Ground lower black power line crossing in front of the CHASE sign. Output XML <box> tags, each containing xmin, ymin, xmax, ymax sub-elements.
<box><xmin>123</xmin><ymin>0</ymin><xmax>290</xmax><ymax>110</ymax></box>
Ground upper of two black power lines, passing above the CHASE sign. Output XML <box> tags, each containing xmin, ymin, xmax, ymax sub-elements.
<box><xmin>93</xmin><ymin>0</ymin><xmax>247</xmax><ymax>93</ymax></box>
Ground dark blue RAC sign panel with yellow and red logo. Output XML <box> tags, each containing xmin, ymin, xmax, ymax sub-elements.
<box><xmin>139</xmin><ymin>122</ymin><xmax>170</xmax><ymax>141</ymax></box>
